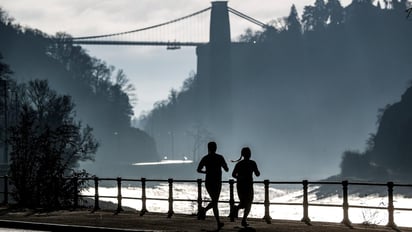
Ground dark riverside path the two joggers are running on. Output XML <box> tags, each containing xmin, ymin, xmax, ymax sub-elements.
<box><xmin>0</xmin><ymin>208</ymin><xmax>412</xmax><ymax>232</ymax></box>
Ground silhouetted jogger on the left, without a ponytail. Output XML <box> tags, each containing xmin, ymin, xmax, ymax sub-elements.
<box><xmin>197</xmin><ymin>142</ymin><xmax>229</xmax><ymax>230</ymax></box>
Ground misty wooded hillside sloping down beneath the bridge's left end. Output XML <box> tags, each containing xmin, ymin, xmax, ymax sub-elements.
<box><xmin>0</xmin><ymin>8</ymin><xmax>158</xmax><ymax>176</ymax></box>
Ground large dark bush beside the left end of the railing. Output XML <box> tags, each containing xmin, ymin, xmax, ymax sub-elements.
<box><xmin>8</xmin><ymin>80</ymin><xmax>98</xmax><ymax>209</ymax></box>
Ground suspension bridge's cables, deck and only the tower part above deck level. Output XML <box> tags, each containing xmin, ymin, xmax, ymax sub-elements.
<box><xmin>63</xmin><ymin>1</ymin><xmax>270</xmax><ymax>49</ymax></box>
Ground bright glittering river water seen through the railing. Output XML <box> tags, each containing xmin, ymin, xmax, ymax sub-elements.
<box><xmin>82</xmin><ymin>183</ymin><xmax>412</xmax><ymax>227</ymax></box>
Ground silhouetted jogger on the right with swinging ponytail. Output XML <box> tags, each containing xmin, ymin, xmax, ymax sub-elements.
<box><xmin>232</xmin><ymin>147</ymin><xmax>260</xmax><ymax>226</ymax></box>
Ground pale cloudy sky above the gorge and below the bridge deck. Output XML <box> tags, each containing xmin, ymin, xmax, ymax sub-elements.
<box><xmin>0</xmin><ymin>0</ymin><xmax>350</xmax><ymax>116</ymax></box>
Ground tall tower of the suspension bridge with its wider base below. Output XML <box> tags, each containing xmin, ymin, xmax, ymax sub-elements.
<box><xmin>197</xmin><ymin>1</ymin><xmax>233</xmax><ymax>140</ymax></box>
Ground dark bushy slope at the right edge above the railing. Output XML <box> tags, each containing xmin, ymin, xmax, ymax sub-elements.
<box><xmin>341</xmin><ymin>84</ymin><xmax>412</xmax><ymax>181</ymax></box>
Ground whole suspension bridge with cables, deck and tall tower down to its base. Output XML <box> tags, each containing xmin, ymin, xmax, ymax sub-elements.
<box><xmin>62</xmin><ymin>1</ymin><xmax>273</xmax><ymax>138</ymax></box>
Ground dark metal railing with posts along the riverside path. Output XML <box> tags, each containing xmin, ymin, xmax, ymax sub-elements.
<box><xmin>0</xmin><ymin>176</ymin><xmax>412</xmax><ymax>227</ymax></box>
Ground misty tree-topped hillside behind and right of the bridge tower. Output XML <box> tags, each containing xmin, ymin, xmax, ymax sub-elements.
<box><xmin>142</xmin><ymin>0</ymin><xmax>412</xmax><ymax>179</ymax></box>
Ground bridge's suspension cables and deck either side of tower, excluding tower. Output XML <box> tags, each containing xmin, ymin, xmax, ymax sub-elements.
<box><xmin>58</xmin><ymin>4</ymin><xmax>271</xmax><ymax>49</ymax></box>
